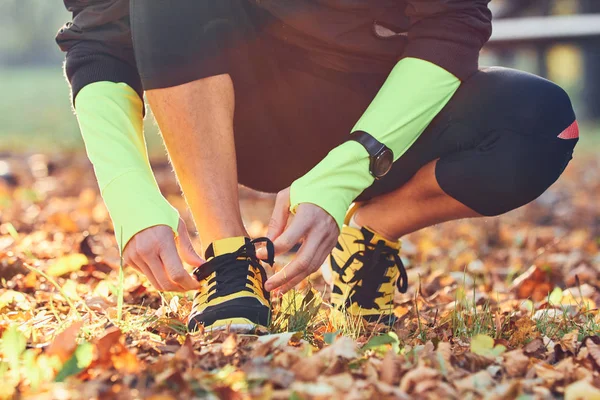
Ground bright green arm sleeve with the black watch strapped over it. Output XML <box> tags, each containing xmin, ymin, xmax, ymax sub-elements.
<box><xmin>290</xmin><ymin>58</ymin><xmax>460</xmax><ymax>228</ymax></box>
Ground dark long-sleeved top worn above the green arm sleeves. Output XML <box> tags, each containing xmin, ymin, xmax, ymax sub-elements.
<box><xmin>56</xmin><ymin>0</ymin><xmax>491</xmax><ymax>101</ymax></box>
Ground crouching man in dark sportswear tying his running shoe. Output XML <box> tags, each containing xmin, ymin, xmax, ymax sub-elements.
<box><xmin>58</xmin><ymin>0</ymin><xmax>578</xmax><ymax>331</ymax></box>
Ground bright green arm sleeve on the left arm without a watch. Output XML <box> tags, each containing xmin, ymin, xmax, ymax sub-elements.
<box><xmin>75</xmin><ymin>82</ymin><xmax>179</xmax><ymax>249</ymax></box>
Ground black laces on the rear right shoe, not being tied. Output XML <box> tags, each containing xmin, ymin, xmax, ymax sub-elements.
<box><xmin>340</xmin><ymin>240</ymin><xmax>408</xmax><ymax>308</ymax></box>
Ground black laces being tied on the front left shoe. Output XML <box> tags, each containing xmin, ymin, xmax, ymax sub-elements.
<box><xmin>194</xmin><ymin>237</ymin><xmax>275</xmax><ymax>301</ymax></box>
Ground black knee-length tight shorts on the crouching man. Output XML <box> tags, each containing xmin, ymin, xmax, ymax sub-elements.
<box><xmin>131</xmin><ymin>0</ymin><xmax>578</xmax><ymax>215</ymax></box>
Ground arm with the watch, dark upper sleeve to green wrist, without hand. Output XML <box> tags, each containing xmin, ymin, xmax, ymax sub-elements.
<box><xmin>290</xmin><ymin>0</ymin><xmax>491</xmax><ymax>227</ymax></box>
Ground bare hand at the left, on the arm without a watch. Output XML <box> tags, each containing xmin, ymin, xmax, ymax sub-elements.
<box><xmin>123</xmin><ymin>219</ymin><xmax>205</xmax><ymax>292</ymax></box>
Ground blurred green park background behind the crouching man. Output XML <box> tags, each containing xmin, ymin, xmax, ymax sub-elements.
<box><xmin>0</xmin><ymin>0</ymin><xmax>600</xmax><ymax>156</ymax></box>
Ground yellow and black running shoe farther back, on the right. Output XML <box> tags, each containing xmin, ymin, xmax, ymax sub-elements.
<box><xmin>329</xmin><ymin>217</ymin><xmax>408</xmax><ymax>324</ymax></box>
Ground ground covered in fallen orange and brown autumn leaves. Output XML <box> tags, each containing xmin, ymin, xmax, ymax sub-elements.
<box><xmin>0</xmin><ymin>155</ymin><xmax>600</xmax><ymax>400</ymax></box>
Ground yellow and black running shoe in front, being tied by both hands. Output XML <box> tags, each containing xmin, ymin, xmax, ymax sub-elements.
<box><xmin>188</xmin><ymin>237</ymin><xmax>274</xmax><ymax>333</ymax></box>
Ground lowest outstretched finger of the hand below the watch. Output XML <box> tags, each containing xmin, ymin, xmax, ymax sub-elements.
<box><xmin>265</xmin><ymin>231</ymin><xmax>322</xmax><ymax>291</ymax></box>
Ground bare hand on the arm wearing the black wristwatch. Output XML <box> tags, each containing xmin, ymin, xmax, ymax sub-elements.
<box><xmin>259</xmin><ymin>188</ymin><xmax>340</xmax><ymax>293</ymax></box>
